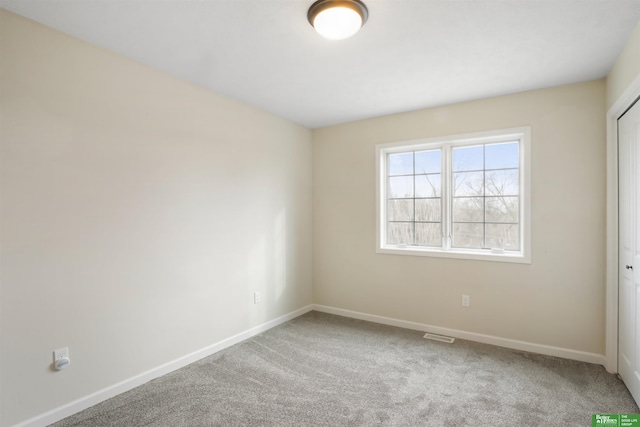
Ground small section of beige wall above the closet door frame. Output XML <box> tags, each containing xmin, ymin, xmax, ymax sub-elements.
<box><xmin>607</xmin><ymin>23</ymin><xmax>640</xmax><ymax>110</ymax></box>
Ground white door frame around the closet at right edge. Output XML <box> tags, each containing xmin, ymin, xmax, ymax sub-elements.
<box><xmin>604</xmin><ymin>75</ymin><xmax>640</xmax><ymax>373</ymax></box>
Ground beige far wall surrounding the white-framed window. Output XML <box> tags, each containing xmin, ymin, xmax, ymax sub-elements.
<box><xmin>313</xmin><ymin>80</ymin><xmax>605</xmax><ymax>354</ymax></box>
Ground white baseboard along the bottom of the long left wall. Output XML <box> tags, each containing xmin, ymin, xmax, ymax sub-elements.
<box><xmin>13</xmin><ymin>305</ymin><xmax>313</xmax><ymax>427</ymax></box>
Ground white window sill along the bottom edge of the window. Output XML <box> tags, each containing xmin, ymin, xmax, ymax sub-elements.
<box><xmin>376</xmin><ymin>246</ymin><xmax>531</xmax><ymax>264</ymax></box>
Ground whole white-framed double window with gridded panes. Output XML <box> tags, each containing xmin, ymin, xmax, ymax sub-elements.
<box><xmin>376</xmin><ymin>127</ymin><xmax>531</xmax><ymax>263</ymax></box>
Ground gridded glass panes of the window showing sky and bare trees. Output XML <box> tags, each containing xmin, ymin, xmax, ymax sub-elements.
<box><xmin>386</xmin><ymin>141</ymin><xmax>520</xmax><ymax>251</ymax></box>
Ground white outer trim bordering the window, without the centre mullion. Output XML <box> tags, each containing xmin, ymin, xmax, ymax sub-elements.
<box><xmin>376</xmin><ymin>126</ymin><xmax>531</xmax><ymax>264</ymax></box>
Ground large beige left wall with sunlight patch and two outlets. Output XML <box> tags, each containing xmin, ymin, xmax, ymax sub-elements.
<box><xmin>0</xmin><ymin>9</ymin><xmax>312</xmax><ymax>426</ymax></box>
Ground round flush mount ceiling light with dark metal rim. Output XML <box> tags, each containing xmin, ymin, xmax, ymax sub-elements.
<box><xmin>307</xmin><ymin>0</ymin><xmax>369</xmax><ymax>40</ymax></box>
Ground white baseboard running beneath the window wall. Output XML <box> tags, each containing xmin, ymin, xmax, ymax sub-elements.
<box><xmin>312</xmin><ymin>304</ymin><xmax>605</xmax><ymax>365</ymax></box>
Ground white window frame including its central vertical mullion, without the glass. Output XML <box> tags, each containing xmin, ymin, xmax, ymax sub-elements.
<box><xmin>376</xmin><ymin>126</ymin><xmax>531</xmax><ymax>264</ymax></box>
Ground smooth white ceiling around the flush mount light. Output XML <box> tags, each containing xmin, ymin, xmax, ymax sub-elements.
<box><xmin>0</xmin><ymin>0</ymin><xmax>640</xmax><ymax>128</ymax></box>
